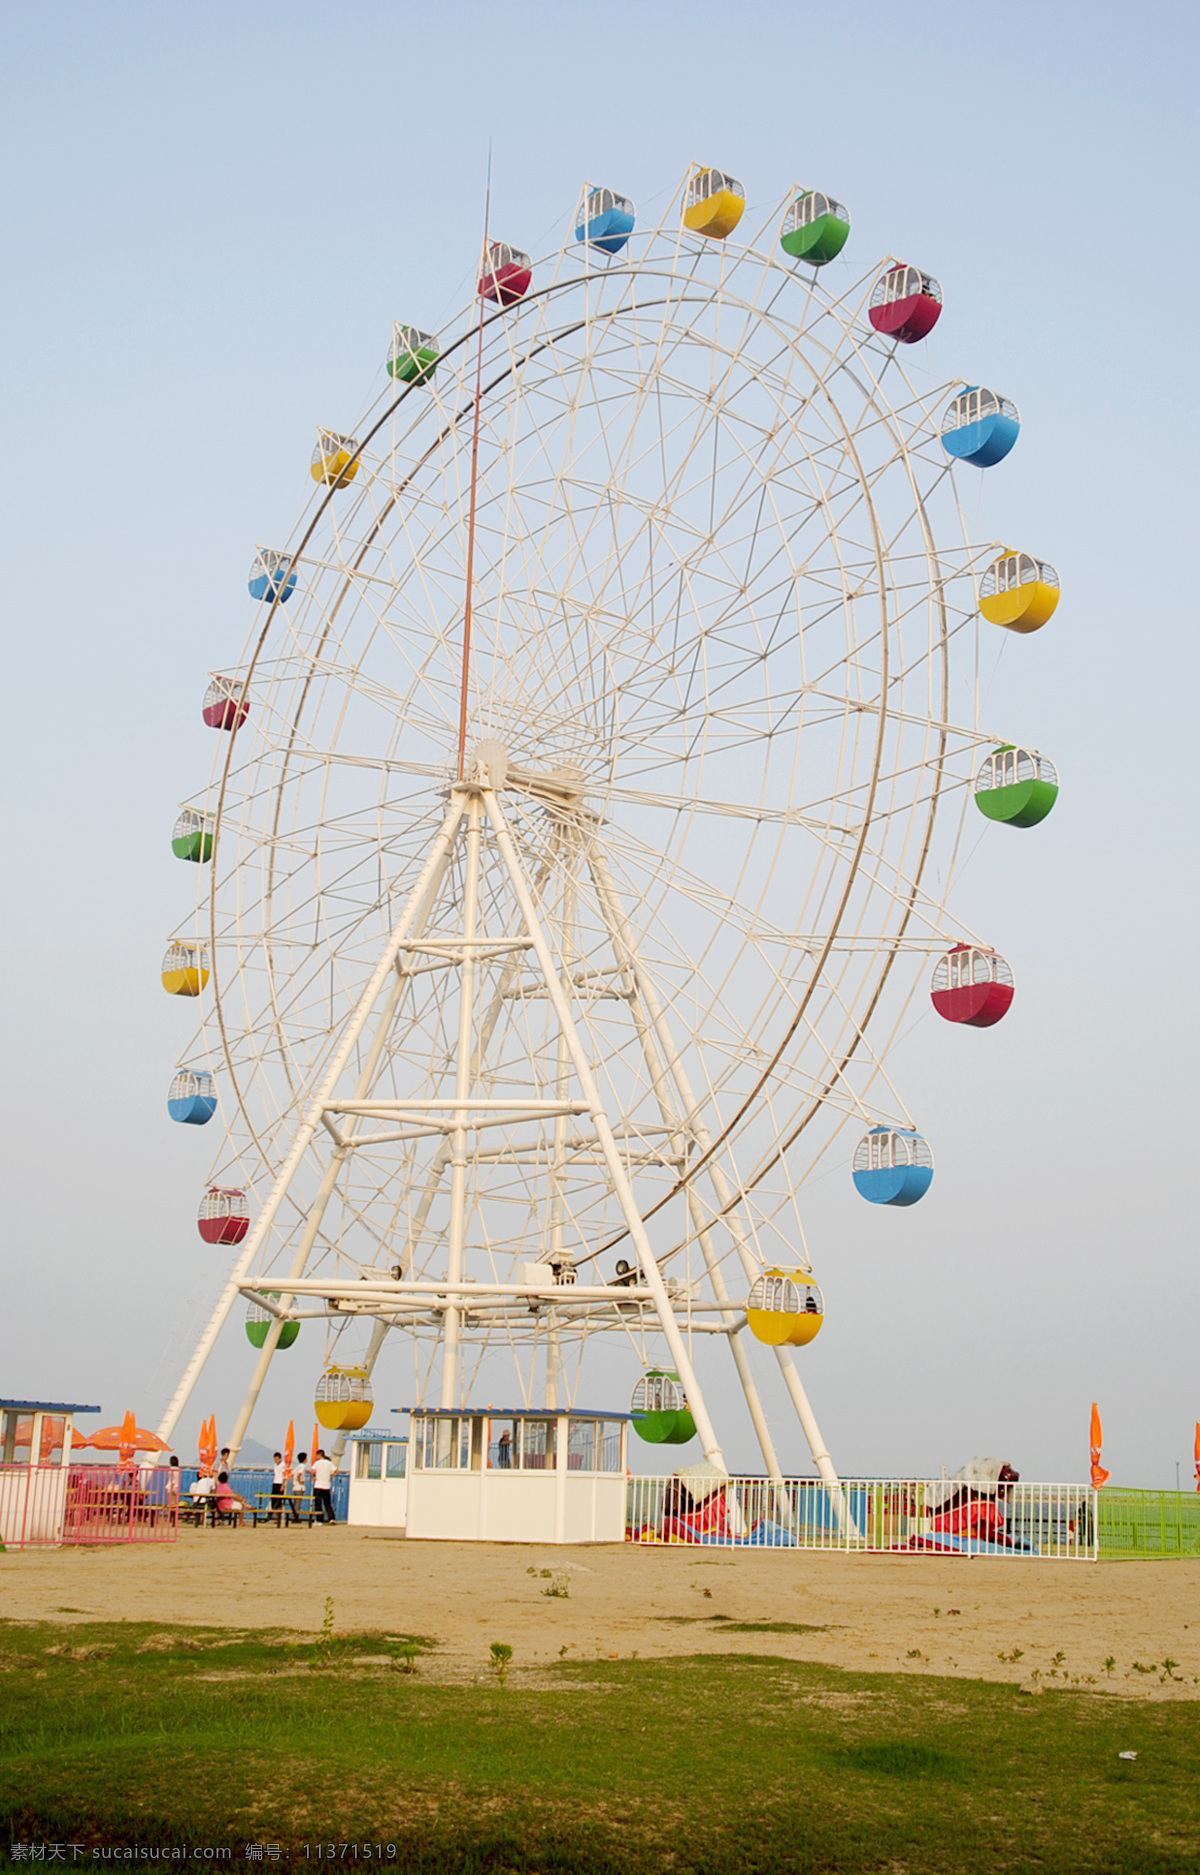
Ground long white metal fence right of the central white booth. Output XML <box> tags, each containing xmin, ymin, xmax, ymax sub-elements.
<box><xmin>624</xmin><ymin>1478</ymin><xmax>1099</xmax><ymax>1562</ymax></box>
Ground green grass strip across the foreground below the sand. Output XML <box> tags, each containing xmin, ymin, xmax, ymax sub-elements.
<box><xmin>0</xmin><ymin>1622</ymin><xmax>1200</xmax><ymax>1875</ymax></box>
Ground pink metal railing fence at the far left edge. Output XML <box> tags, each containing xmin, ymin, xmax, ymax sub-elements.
<box><xmin>0</xmin><ymin>1464</ymin><xmax>180</xmax><ymax>1549</ymax></box>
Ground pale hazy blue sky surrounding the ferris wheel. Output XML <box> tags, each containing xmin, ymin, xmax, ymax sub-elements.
<box><xmin>0</xmin><ymin>0</ymin><xmax>1200</xmax><ymax>1485</ymax></box>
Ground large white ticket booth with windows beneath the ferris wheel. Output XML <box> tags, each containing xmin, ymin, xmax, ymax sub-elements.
<box><xmin>401</xmin><ymin>1406</ymin><xmax>628</xmax><ymax>1543</ymax></box>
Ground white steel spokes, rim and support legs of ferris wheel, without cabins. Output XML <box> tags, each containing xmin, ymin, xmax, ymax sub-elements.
<box><xmin>154</xmin><ymin>168</ymin><xmax>1042</xmax><ymax>1478</ymax></box>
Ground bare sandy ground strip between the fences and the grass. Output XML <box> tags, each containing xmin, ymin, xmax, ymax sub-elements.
<box><xmin>0</xmin><ymin>1524</ymin><xmax>1200</xmax><ymax>1699</ymax></box>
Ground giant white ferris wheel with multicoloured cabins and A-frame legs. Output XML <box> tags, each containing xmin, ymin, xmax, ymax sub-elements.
<box><xmin>151</xmin><ymin>167</ymin><xmax>1058</xmax><ymax>1479</ymax></box>
